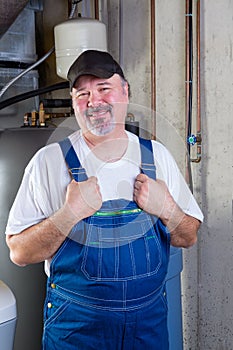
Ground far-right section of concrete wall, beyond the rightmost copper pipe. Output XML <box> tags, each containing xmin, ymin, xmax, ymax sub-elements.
<box><xmin>198</xmin><ymin>0</ymin><xmax>233</xmax><ymax>350</ymax></box>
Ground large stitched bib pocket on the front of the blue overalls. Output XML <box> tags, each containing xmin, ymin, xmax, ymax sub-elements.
<box><xmin>81</xmin><ymin>212</ymin><xmax>162</xmax><ymax>281</ymax></box>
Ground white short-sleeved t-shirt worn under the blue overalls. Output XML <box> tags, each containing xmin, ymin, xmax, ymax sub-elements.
<box><xmin>6</xmin><ymin>130</ymin><xmax>203</xmax><ymax>270</ymax></box>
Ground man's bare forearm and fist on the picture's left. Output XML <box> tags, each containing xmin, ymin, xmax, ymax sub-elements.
<box><xmin>6</xmin><ymin>177</ymin><xmax>102</xmax><ymax>266</ymax></box>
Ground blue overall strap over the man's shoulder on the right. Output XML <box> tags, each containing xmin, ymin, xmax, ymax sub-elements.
<box><xmin>139</xmin><ymin>137</ymin><xmax>156</xmax><ymax>180</ymax></box>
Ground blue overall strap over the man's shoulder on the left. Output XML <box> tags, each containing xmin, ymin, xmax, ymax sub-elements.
<box><xmin>58</xmin><ymin>137</ymin><xmax>87</xmax><ymax>182</ymax></box>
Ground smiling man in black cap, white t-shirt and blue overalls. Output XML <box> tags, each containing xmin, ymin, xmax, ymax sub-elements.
<box><xmin>6</xmin><ymin>50</ymin><xmax>203</xmax><ymax>350</ymax></box>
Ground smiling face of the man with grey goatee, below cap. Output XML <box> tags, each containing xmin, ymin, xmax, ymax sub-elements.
<box><xmin>72</xmin><ymin>74</ymin><xmax>128</xmax><ymax>136</ymax></box>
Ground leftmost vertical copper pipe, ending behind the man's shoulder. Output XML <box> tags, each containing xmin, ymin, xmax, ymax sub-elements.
<box><xmin>150</xmin><ymin>0</ymin><xmax>156</xmax><ymax>140</ymax></box>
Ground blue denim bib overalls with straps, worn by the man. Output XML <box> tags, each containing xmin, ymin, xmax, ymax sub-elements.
<box><xmin>43</xmin><ymin>139</ymin><xmax>170</xmax><ymax>350</ymax></box>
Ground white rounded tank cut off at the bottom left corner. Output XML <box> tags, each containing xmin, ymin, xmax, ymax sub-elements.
<box><xmin>0</xmin><ymin>281</ymin><xmax>17</xmax><ymax>350</ymax></box>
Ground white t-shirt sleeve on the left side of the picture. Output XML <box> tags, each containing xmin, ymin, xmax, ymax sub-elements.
<box><xmin>6</xmin><ymin>144</ymin><xmax>70</xmax><ymax>234</ymax></box>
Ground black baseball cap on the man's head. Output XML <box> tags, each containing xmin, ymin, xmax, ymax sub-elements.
<box><xmin>67</xmin><ymin>50</ymin><xmax>125</xmax><ymax>89</ymax></box>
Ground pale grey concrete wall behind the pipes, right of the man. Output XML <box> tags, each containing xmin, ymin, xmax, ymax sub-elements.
<box><xmin>102</xmin><ymin>0</ymin><xmax>233</xmax><ymax>350</ymax></box>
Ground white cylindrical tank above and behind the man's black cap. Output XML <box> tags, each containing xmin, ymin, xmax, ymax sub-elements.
<box><xmin>54</xmin><ymin>18</ymin><xmax>107</xmax><ymax>79</ymax></box>
